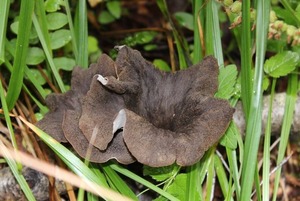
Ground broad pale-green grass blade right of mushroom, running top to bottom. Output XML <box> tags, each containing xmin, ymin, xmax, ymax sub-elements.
<box><xmin>240</xmin><ymin>0</ymin><xmax>270</xmax><ymax>200</ymax></box>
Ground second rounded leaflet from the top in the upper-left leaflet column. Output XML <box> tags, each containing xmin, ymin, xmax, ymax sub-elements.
<box><xmin>46</xmin><ymin>12</ymin><xmax>68</xmax><ymax>30</ymax></box>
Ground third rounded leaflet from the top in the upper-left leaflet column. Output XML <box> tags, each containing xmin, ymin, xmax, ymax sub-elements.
<box><xmin>50</xmin><ymin>29</ymin><xmax>72</xmax><ymax>50</ymax></box>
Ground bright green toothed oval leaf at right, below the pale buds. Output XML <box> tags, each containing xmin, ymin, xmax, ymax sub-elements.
<box><xmin>264</xmin><ymin>51</ymin><xmax>299</xmax><ymax>78</ymax></box>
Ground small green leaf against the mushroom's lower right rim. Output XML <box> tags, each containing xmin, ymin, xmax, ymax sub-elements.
<box><xmin>220</xmin><ymin>122</ymin><xmax>239</xmax><ymax>149</ymax></box>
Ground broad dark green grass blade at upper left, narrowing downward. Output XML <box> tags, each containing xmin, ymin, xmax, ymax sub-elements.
<box><xmin>6</xmin><ymin>0</ymin><xmax>34</xmax><ymax>110</ymax></box>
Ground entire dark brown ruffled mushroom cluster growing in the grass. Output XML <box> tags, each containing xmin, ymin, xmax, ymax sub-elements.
<box><xmin>37</xmin><ymin>46</ymin><xmax>234</xmax><ymax>167</ymax></box>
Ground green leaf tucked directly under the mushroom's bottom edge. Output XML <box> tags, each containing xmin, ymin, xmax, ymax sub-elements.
<box><xmin>143</xmin><ymin>164</ymin><xmax>180</xmax><ymax>181</ymax></box>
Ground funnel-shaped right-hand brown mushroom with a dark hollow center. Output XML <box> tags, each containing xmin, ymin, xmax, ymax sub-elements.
<box><xmin>99</xmin><ymin>47</ymin><xmax>234</xmax><ymax>167</ymax></box>
